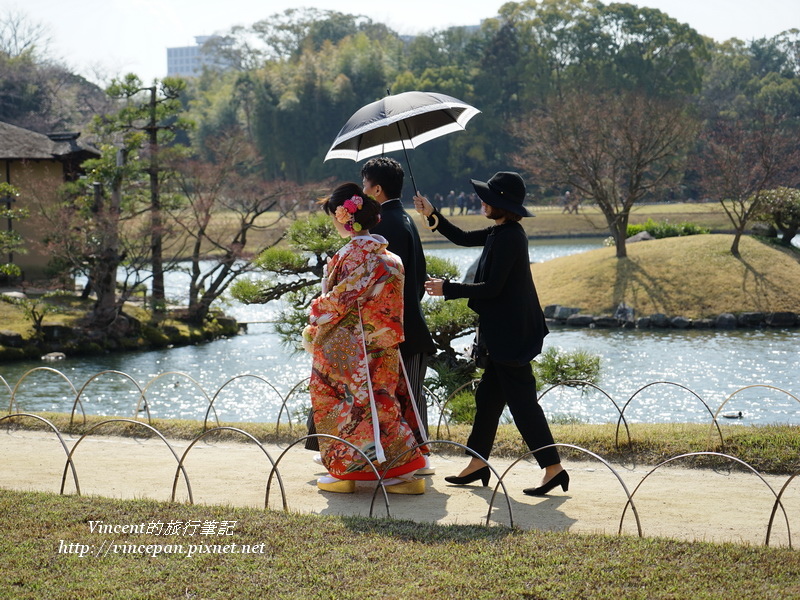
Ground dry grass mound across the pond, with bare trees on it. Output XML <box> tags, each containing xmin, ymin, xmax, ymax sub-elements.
<box><xmin>532</xmin><ymin>234</ymin><xmax>800</xmax><ymax>319</ymax></box>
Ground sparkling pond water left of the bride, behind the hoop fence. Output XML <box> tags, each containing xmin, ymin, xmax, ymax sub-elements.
<box><xmin>0</xmin><ymin>324</ymin><xmax>310</xmax><ymax>422</ymax></box>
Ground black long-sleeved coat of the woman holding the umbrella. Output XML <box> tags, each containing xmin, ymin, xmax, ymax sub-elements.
<box><xmin>436</xmin><ymin>211</ymin><xmax>549</xmax><ymax>365</ymax></box>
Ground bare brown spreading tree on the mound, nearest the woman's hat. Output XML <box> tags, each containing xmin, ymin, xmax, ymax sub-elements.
<box><xmin>514</xmin><ymin>90</ymin><xmax>696</xmax><ymax>258</ymax></box>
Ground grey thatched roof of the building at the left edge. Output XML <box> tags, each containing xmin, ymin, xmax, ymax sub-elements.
<box><xmin>0</xmin><ymin>121</ymin><xmax>100</xmax><ymax>162</ymax></box>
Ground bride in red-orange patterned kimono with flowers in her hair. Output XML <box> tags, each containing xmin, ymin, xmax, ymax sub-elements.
<box><xmin>303</xmin><ymin>183</ymin><xmax>425</xmax><ymax>494</ymax></box>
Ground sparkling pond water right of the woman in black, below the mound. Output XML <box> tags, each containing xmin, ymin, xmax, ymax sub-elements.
<box><xmin>542</xmin><ymin>328</ymin><xmax>800</xmax><ymax>424</ymax></box>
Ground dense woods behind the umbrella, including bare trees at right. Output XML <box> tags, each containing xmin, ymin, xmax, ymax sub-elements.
<box><xmin>190</xmin><ymin>0</ymin><xmax>800</xmax><ymax>257</ymax></box>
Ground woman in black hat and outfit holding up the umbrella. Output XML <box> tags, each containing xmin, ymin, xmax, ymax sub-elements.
<box><xmin>414</xmin><ymin>171</ymin><xmax>569</xmax><ymax>496</ymax></box>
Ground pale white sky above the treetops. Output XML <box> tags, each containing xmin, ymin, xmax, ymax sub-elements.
<box><xmin>7</xmin><ymin>0</ymin><xmax>800</xmax><ymax>84</ymax></box>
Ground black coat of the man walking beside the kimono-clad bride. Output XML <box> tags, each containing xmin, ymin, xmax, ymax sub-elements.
<box><xmin>370</xmin><ymin>200</ymin><xmax>435</xmax><ymax>356</ymax></box>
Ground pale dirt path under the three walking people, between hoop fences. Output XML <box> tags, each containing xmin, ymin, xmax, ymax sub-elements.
<box><xmin>0</xmin><ymin>430</ymin><xmax>800</xmax><ymax>547</ymax></box>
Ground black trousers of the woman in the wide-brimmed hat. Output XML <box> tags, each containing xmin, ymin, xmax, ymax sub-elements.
<box><xmin>467</xmin><ymin>357</ymin><xmax>561</xmax><ymax>468</ymax></box>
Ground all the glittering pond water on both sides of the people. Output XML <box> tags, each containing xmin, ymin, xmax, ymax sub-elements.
<box><xmin>0</xmin><ymin>239</ymin><xmax>800</xmax><ymax>425</ymax></box>
